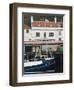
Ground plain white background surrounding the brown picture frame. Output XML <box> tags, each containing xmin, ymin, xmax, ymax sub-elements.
<box><xmin>0</xmin><ymin>0</ymin><xmax>74</xmax><ymax>90</ymax></box>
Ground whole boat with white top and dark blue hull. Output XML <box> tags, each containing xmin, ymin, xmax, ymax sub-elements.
<box><xmin>24</xmin><ymin>58</ymin><xmax>55</xmax><ymax>73</ymax></box>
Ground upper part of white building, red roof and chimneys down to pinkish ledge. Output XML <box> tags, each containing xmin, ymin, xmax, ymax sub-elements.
<box><xmin>24</xmin><ymin>16</ymin><xmax>63</xmax><ymax>42</ymax></box>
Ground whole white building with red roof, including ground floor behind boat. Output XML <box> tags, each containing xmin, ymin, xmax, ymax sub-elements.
<box><xmin>24</xmin><ymin>16</ymin><xmax>63</xmax><ymax>62</ymax></box>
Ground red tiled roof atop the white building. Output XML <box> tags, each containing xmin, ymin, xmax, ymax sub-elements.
<box><xmin>32</xmin><ymin>21</ymin><xmax>63</xmax><ymax>27</ymax></box>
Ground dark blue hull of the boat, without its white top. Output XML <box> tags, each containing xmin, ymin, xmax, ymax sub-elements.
<box><xmin>24</xmin><ymin>59</ymin><xmax>55</xmax><ymax>73</ymax></box>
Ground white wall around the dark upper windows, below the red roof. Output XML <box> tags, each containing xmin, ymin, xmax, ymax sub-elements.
<box><xmin>24</xmin><ymin>29</ymin><xmax>63</xmax><ymax>41</ymax></box>
